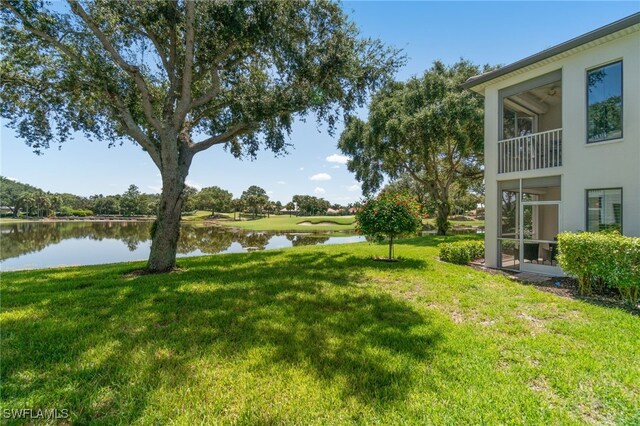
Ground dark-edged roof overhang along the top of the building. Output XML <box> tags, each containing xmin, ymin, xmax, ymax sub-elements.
<box><xmin>462</xmin><ymin>12</ymin><xmax>640</xmax><ymax>93</ymax></box>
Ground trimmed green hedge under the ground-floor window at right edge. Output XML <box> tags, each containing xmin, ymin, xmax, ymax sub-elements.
<box><xmin>558</xmin><ymin>232</ymin><xmax>640</xmax><ymax>304</ymax></box>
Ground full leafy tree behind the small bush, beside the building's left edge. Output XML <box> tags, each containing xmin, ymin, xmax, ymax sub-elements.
<box><xmin>338</xmin><ymin>60</ymin><xmax>484</xmax><ymax>234</ymax></box>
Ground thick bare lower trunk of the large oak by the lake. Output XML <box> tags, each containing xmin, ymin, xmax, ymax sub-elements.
<box><xmin>147</xmin><ymin>145</ymin><xmax>192</xmax><ymax>273</ymax></box>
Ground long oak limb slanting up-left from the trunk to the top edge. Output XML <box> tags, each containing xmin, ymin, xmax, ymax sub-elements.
<box><xmin>67</xmin><ymin>0</ymin><xmax>162</xmax><ymax>133</ymax></box>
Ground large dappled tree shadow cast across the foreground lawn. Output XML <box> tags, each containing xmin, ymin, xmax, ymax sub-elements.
<box><xmin>1</xmin><ymin>251</ymin><xmax>441</xmax><ymax>422</ymax></box>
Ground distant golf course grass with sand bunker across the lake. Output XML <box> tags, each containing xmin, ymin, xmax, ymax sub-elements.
<box><xmin>219</xmin><ymin>215</ymin><xmax>356</xmax><ymax>232</ymax></box>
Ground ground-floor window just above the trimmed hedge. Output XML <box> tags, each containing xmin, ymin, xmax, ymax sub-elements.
<box><xmin>587</xmin><ymin>188</ymin><xmax>622</xmax><ymax>232</ymax></box>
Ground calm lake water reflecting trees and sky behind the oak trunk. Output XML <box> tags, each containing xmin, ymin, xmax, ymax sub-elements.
<box><xmin>0</xmin><ymin>222</ymin><xmax>365</xmax><ymax>271</ymax></box>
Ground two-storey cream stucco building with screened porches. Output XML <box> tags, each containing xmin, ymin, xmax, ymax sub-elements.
<box><xmin>465</xmin><ymin>13</ymin><xmax>640</xmax><ymax>274</ymax></box>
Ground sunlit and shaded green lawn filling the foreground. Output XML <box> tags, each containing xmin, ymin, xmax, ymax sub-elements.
<box><xmin>0</xmin><ymin>237</ymin><xmax>640</xmax><ymax>425</ymax></box>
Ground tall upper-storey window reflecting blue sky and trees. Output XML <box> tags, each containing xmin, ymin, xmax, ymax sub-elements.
<box><xmin>587</xmin><ymin>61</ymin><xmax>622</xmax><ymax>143</ymax></box>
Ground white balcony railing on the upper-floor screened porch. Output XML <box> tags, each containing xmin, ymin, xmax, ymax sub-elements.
<box><xmin>498</xmin><ymin>129</ymin><xmax>562</xmax><ymax>173</ymax></box>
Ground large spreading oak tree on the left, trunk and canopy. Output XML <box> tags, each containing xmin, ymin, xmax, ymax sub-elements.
<box><xmin>0</xmin><ymin>0</ymin><xmax>401</xmax><ymax>272</ymax></box>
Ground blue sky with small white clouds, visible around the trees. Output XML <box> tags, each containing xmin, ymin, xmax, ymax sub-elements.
<box><xmin>0</xmin><ymin>0</ymin><xmax>640</xmax><ymax>204</ymax></box>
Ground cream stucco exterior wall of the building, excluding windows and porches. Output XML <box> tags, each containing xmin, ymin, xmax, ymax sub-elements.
<box><xmin>484</xmin><ymin>31</ymin><xmax>640</xmax><ymax>267</ymax></box>
